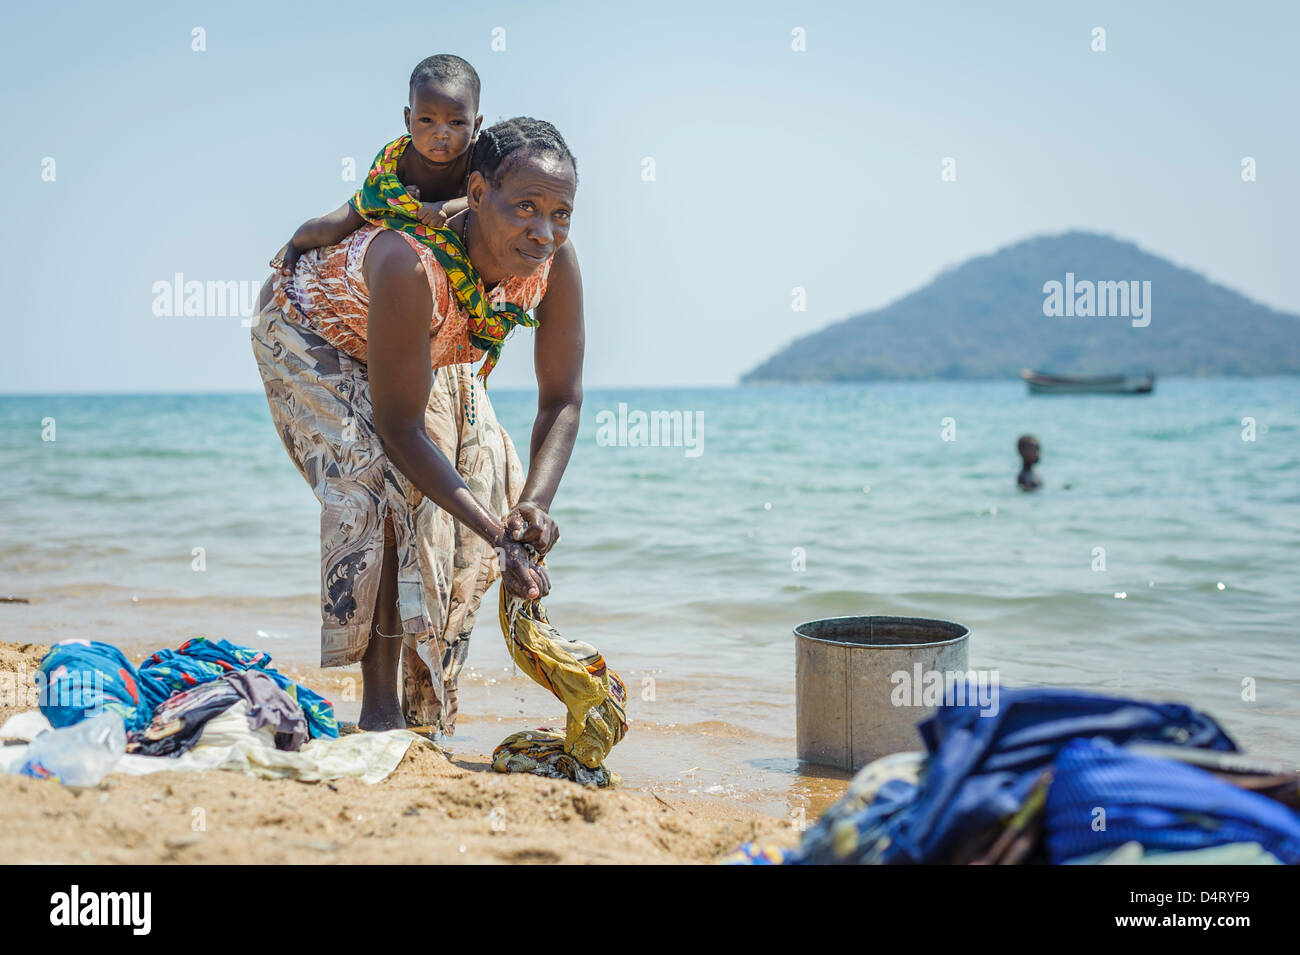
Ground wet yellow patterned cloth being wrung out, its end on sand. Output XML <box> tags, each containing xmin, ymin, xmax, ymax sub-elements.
<box><xmin>493</xmin><ymin>571</ymin><xmax>628</xmax><ymax>786</ymax></box>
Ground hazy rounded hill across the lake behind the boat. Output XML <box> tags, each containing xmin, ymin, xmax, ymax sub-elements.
<box><xmin>741</xmin><ymin>233</ymin><xmax>1300</xmax><ymax>383</ymax></box>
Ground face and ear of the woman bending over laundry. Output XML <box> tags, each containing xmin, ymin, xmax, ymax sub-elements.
<box><xmin>468</xmin><ymin>153</ymin><xmax>577</xmax><ymax>281</ymax></box>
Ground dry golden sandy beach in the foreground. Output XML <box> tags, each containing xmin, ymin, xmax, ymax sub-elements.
<box><xmin>0</xmin><ymin>643</ymin><xmax>798</xmax><ymax>864</ymax></box>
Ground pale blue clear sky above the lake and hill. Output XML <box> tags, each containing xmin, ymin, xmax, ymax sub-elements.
<box><xmin>0</xmin><ymin>0</ymin><xmax>1300</xmax><ymax>394</ymax></box>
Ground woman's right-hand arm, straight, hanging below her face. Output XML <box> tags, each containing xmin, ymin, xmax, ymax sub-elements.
<box><xmin>506</xmin><ymin>243</ymin><xmax>586</xmax><ymax>554</ymax></box>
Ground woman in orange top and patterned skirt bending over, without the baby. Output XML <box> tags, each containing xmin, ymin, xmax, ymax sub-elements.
<box><xmin>252</xmin><ymin>118</ymin><xmax>584</xmax><ymax>733</ymax></box>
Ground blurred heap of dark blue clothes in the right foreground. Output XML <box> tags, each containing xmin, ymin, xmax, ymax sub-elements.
<box><xmin>723</xmin><ymin>689</ymin><xmax>1300</xmax><ymax>865</ymax></box>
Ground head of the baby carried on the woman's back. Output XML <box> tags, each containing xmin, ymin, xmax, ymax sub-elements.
<box><xmin>403</xmin><ymin>53</ymin><xmax>484</xmax><ymax>165</ymax></box>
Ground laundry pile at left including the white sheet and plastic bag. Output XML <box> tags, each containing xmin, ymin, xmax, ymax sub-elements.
<box><xmin>0</xmin><ymin>637</ymin><xmax>437</xmax><ymax>786</ymax></box>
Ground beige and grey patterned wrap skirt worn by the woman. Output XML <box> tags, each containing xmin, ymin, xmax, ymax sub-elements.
<box><xmin>252</xmin><ymin>287</ymin><xmax>524</xmax><ymax>734</ymax></box>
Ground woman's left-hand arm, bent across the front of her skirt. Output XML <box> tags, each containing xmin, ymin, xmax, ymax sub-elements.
<box><xmin>361</xmin><ymin>233</ymin><xmax>549</xmax><ymax>599</ymax></box>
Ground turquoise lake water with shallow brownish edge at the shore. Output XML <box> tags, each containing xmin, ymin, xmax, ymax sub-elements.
<box><xmin>0</xmin><ymin>379</ymin><xmax>1300</xmax><ymax>812</ymax></box>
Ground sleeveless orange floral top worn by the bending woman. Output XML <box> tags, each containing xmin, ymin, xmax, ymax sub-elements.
<box><xmin>274</xmin><ymin>225</ymin><xmax>551</xmax><ymax>368</ymax></box>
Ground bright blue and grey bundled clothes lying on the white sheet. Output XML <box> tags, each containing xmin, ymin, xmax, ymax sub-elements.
<box><xmin>39</xmin><ymin>637</ymin><xmax>338</xmax><ymax>756</ymax></box>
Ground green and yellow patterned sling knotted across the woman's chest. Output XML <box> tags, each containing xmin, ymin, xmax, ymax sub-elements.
<box><xmin>351</xmin><ymin>135</ymin><xmax>538</xmax><ymax>387</ymax></box>
